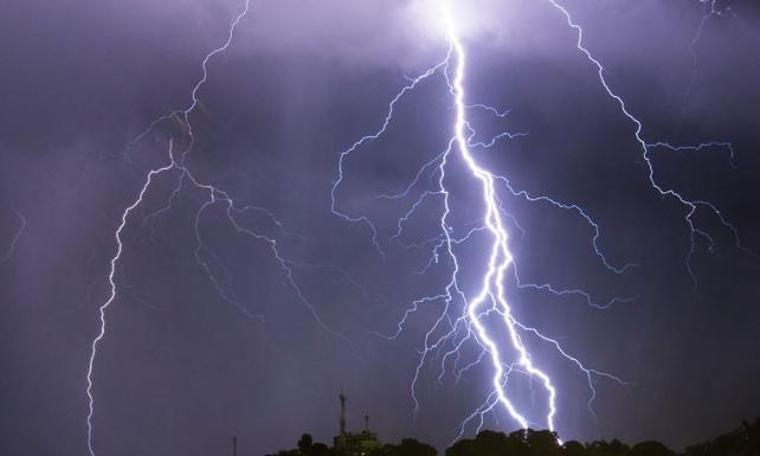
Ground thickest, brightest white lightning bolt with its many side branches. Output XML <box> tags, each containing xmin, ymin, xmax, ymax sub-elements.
<box><xmin>331</xmin><ymin>1</ymin><xmax>635</xmax><ymax>442</ymax></box>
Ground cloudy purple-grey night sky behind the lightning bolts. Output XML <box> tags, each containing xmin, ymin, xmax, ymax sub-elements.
<box><xmin>0</xmin><ymin>0</ymin><xmax>760</xmax><ymax>456</ymax></box>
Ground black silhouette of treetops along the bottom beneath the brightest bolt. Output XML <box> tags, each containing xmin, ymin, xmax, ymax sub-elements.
<box><xmin>268</xmin><ymin>418</ymin><xmax>760</xmax><ymax>456</ymax></box>
